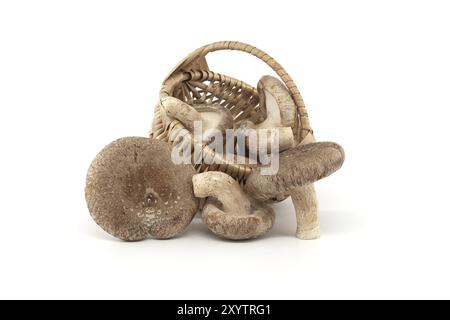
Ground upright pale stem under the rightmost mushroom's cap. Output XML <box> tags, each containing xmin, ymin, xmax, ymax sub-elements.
<box><xmin>291</xmin><ymin>184</ymin><xmax>320</xmax><ymax>240</ymax></box>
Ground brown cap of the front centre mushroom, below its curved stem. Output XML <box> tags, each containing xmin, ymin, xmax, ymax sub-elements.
<box><xmin>203</xmin><ymin>197</ymin><xmax>275</xmax><ymax>240</ymax></box>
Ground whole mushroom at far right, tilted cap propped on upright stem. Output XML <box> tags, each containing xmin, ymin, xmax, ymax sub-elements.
<box><xmin>245</xmin><ymin>142</ymin><xmax>344</xmax><ymax>240</ymax></box>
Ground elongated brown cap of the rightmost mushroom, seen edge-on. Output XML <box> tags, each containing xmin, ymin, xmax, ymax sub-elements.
<box><xmin>245</xmin><ymin>142</ymin><xmax>345</xmax><ymax>201</ymax></box>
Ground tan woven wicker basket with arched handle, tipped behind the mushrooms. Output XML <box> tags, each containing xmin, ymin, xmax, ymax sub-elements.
<box><xmin>150</xmin><ymin>41</ymin><xmax>312</xmax><ymax>182</ymax></box>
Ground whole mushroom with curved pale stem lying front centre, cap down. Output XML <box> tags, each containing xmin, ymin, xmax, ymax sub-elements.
<box><xmin>192</xmin><ymin>171</ymin><xmax>275</xmax><ymax>240</ymax></box>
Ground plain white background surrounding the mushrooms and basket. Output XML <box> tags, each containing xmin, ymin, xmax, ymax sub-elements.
<box><xmin>0</xmin><ymin>0</ymin><xmax>450</xmax><ymax>299</ymax></box>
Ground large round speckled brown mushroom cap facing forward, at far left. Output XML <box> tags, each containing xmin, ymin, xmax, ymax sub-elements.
<box><xmin>85</xmin><ymin>137</ymin><xmax>198</xmax><ymax>241</ymax></box>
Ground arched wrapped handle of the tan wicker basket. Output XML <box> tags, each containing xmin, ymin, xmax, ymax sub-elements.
<box><xmin>165</xmin><ymin>41</ymin><xmax>312</xmax><ymax>141</ymax></box>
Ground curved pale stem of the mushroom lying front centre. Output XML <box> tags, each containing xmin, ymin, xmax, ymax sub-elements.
<box><xmin>192</xmin><ymin>171</ymin><xmax>251</xmax><ymax>214</ymax></box>
